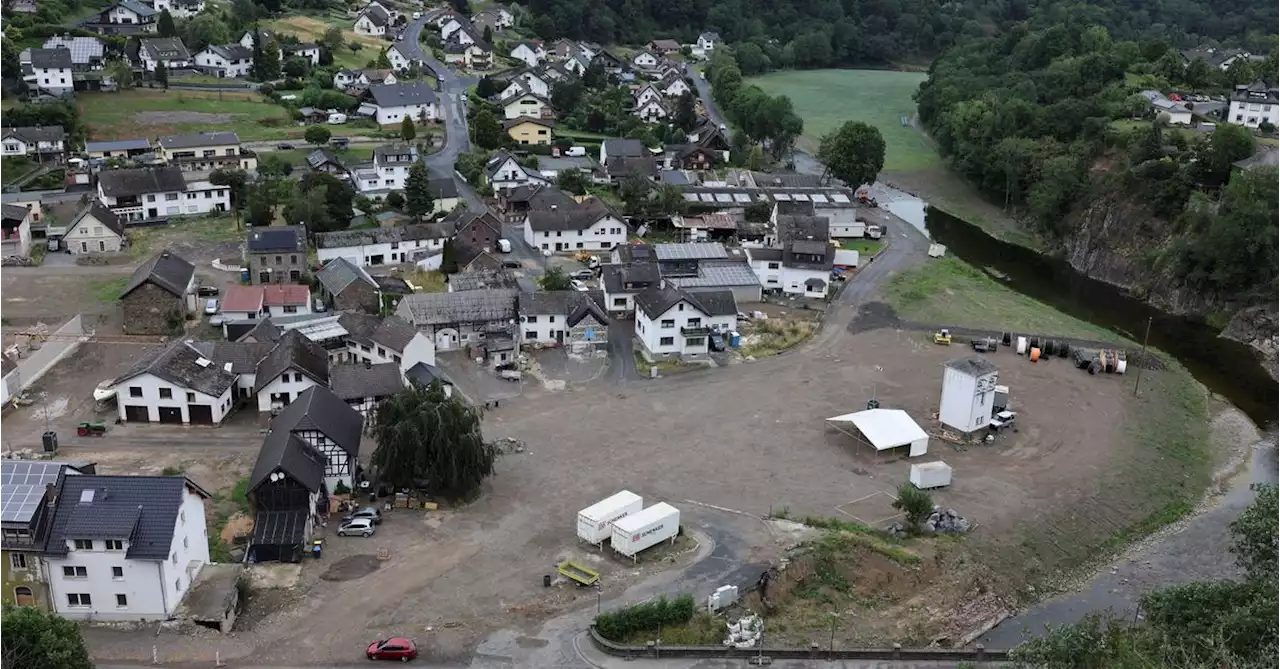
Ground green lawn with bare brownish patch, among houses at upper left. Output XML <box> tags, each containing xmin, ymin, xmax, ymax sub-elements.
<box><xmin>76</xmin><ymin>88</ymin><xmax>294</xmax><ymax>142</ymax></box>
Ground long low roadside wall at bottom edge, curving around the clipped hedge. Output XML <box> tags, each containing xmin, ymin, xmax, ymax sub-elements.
<box><xmin>590</xmin><ymin>626</ymin><xmax>1009</xmax><ymax>663</ymax></box>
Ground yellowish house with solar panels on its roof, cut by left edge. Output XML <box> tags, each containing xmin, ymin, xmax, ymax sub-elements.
<box><xmin>0</xmin><ymin>459</ymin><xmax>93</xmax><ymax>611</ymax></box>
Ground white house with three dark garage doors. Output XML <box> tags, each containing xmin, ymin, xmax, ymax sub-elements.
<box><xmin>111</xmin><ymin>339</ymin><xmax>237</xmax><ymax>425</ymax></box>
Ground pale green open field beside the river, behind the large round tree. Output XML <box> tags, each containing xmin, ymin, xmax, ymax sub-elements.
<box><xmin>748</xmin><ymin>69</ymin><xmax>940</xmax><ymax>171</ymax></box>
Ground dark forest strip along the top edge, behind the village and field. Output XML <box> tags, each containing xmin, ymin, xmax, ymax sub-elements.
<box><xmin>520</xmin><ymin>0</ymin><xmax>1280</xmax><ymax>68</ymax></box>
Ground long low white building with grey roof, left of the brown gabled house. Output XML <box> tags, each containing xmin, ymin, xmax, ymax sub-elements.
<box><xmin>316</xmin><ymin>223</ymin><xmax>453</xmax><ymax>267</ymax></box>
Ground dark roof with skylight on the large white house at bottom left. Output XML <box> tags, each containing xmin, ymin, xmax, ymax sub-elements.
<box><xmin>47</xmin><ymin>476</ymin><xmax>209</xmax><ymax>568</ymax></box>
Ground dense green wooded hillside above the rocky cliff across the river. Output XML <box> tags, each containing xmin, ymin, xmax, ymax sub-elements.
<box><xmin>916</xmin><ymin>18</ymin><xmax>1280</xmax><ymax>298</ymax></box>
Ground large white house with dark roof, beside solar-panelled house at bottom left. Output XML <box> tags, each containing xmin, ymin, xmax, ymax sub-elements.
<box><xmin>44</xmin><ymin>475</ymin><xmax>210</xmax><ymax>623</ymax></box>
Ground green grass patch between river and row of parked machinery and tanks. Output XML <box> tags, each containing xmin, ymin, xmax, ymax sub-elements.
<box><xmin>884</xmin><ymin>257</ymin><xmax>1125</xmax><ymax>343</ymax></box>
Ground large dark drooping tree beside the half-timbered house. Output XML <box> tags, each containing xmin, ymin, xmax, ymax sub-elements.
<box><xmin>369</xmin><ymin>381</ymin><xmax>498</xmax><ymax>500</ymax></box>
